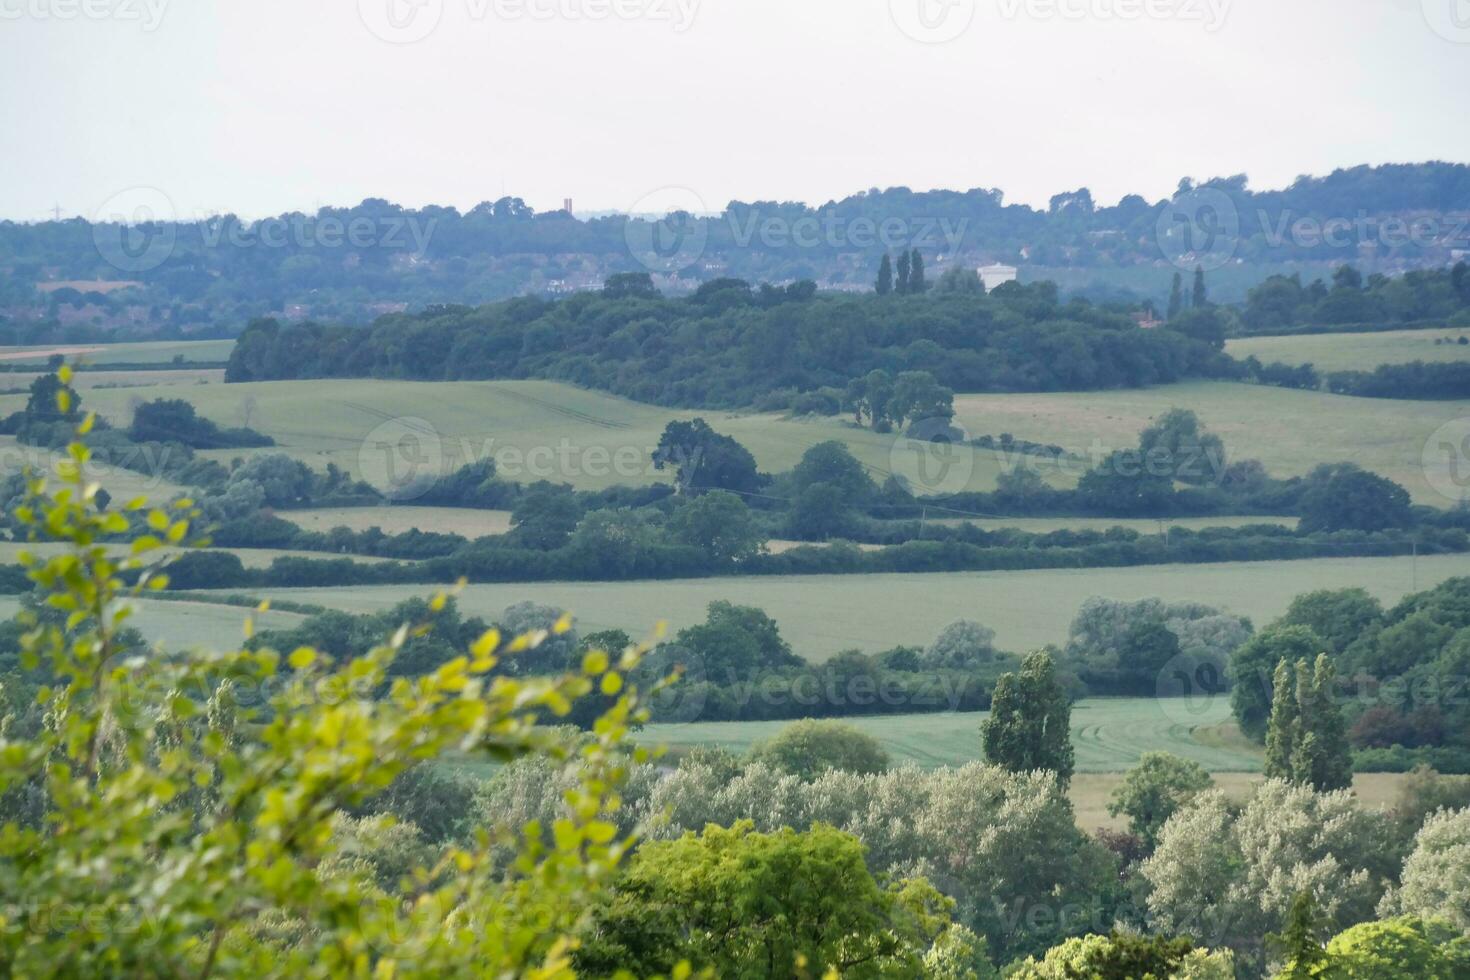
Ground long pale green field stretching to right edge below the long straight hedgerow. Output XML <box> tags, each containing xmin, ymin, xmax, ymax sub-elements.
<box><xmin>204</xmin><ymin>555</ymin><xmax>1470</xmax><ymax>660</ymax></box>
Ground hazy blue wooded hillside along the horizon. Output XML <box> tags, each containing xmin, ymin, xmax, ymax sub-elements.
<box><xmin>0</xmin><ymin>163</ymin><xmax>1470</xmax><ymax>336</ymax></box>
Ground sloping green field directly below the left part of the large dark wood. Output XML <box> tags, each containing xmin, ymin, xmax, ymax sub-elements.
<box><xmin>0</xmin><ymin>372</ymin><xmax>1052</xmax><ymax>491</ymax></box>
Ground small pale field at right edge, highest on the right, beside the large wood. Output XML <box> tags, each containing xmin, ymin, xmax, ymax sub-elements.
<box><xmin>1225</xmin><ymin>328</ymin><xmax>1470</xmax><ymax>372</ymax></box>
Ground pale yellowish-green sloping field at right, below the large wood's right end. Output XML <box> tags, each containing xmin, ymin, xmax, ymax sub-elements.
<box><xmin>954</xmin><ymin>381</ymin><xmax>1470</xmax><ymax>507</ymax></box>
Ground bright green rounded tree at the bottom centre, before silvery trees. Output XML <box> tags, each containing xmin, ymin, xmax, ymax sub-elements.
<box><xmin>576</xmin><ymin>820</ymin><xmax>948</xmax><ymax>977</ymax></box>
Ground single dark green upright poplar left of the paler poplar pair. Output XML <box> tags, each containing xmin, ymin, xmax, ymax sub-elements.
<box><xmin>980</xmin><ymin>651</ymin><xmax>1075</xmax><ymax>783</ymax></box>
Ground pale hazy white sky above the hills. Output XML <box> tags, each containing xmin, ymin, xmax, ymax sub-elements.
<box><xmin>0</xmin><ymin>0</ymin><xmax>1470</xmax><ymax>219</ymax></box>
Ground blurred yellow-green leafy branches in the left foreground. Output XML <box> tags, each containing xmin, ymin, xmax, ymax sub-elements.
<box><xmin>0</xmin><ymin>402</ymin><xmax>661</xmax><ymax>977</ymax></box>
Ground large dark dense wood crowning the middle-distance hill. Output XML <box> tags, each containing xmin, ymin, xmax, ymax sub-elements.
<box><xmin>225</xmin><ymin>277</ymin><xmax>1238</xmax><ymax>407</ymax></box>
